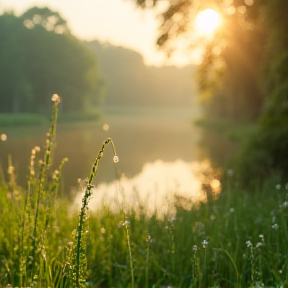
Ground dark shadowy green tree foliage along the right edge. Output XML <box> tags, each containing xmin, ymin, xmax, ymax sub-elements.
<box><xmin>239</xmin><ymin>0</ymin><xmax>288</xmax><ymax>181</ymax></box>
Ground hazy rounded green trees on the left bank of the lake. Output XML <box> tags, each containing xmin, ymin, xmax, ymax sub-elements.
<box><xmin>0</xmin><ymin>7</ymin><xmax>98</xmax><ymax>113</ymax></box>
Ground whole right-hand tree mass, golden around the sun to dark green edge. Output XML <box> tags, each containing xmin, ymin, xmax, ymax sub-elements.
<box><xmin>134</xmin><ymin>0</ymin><xmax>288</xmax><ymax>178</ymax></box>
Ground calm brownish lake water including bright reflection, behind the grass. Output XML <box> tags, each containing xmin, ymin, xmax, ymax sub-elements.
<box><xmin>0</xmin><ymin>109</ymin><xmax>234</xmax><ymax>209</ymax></box>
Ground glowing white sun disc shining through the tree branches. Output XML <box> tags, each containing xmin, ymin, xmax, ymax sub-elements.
<box><xmin>195</xmin><ymin>9</ymin><xmax>220</xmax><ymax>34</ymax></box>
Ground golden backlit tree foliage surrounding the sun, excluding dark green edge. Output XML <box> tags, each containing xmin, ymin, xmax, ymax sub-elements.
<box><xmin>132</xmin><ymin>0</ymin><xmax>265</xmax><ymax>120</ymax></box>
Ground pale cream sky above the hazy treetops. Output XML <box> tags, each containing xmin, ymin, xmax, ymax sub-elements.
<box><xmin>0</xmin><ymin>0</ymin><xmax>198</xmax><ymax>66</ymax></box>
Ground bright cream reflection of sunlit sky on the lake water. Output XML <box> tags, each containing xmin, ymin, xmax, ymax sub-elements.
<box><xmin>75</xmin><ymin>160</ymin><xmax>220</xmax><ymax>215</ymax></box>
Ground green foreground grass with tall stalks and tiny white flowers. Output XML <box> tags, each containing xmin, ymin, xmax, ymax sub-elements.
<box><xmin>0</xmin><ymin>101</ymin><xmax>288</xmax><ymax>288</ymax></box>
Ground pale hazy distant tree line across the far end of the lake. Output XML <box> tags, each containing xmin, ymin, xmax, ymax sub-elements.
<box><xmin>86</xmin><ymin>40</ymin><xmax>199</xmax><ymax>107</ymax></box>
